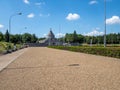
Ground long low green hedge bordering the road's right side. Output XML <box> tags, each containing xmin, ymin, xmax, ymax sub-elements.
<box><xmin>49</xmin><ymin>46</ymin><xmax>120</xmax><ymax>58</ymax></box>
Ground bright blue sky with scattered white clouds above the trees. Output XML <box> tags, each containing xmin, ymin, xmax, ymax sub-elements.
<box><xmin>0</xmin><ymin>0</ymin><xmax>120</xmax><ymax>37</ymax></box>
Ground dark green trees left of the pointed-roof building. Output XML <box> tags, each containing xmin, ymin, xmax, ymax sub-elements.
<box><xmin>0</xmin><ymin>30</ymin><xmax>38</xmax><ymax>43</ymax></box>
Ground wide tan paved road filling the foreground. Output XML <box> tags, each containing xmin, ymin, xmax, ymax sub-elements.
<box><xmin>0</xmin><ymin>47</ymin><xmax>120</xmax><ymax>90</ymax></box>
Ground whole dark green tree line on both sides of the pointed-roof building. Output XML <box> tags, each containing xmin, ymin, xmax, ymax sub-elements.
<box><xmin>0</xmin><ymin>30</ymin><xmax>120</xmax><ymax>44</ymax></box>
